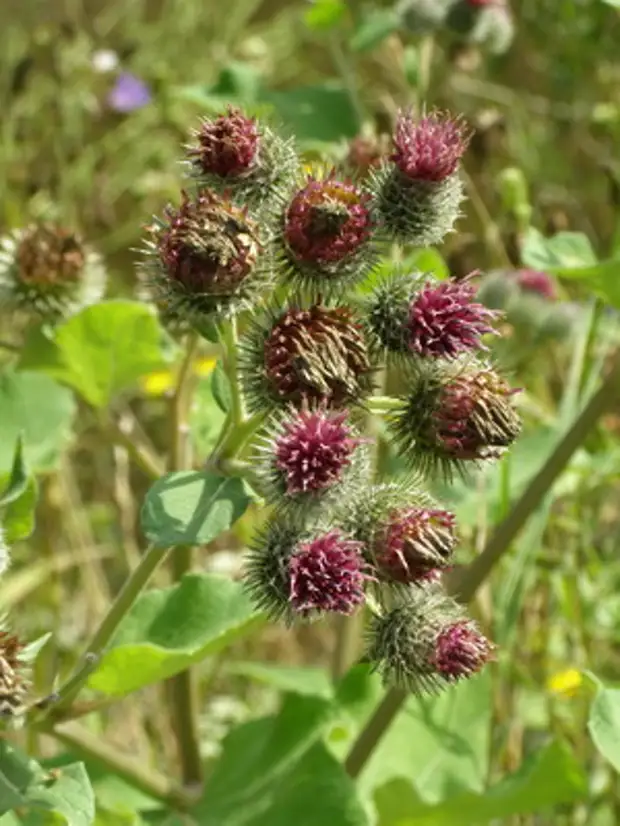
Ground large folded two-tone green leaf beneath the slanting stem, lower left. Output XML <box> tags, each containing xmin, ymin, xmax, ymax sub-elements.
<box><xmin>88</xmin><ymin>574</ymin><xmax>263</xmax><ymax>696</ymax></box>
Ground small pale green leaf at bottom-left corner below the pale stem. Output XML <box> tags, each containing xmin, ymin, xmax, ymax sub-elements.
<box><xmin>26</xmin><ymin>763</ymin><xmax>95</xmax><ymax>826</ymax></box>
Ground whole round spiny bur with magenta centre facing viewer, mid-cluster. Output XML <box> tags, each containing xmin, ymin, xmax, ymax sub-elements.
<box><xmin>259</xmin><ymin>407</ymin><xmax>367</xmax><ymax>515</ymax></box>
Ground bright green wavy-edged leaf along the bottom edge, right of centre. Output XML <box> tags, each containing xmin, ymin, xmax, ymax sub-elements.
<box><xmin>376</xmin><ymin>742</ymin><xmax>588</xmax><ymax>826</ymax></box>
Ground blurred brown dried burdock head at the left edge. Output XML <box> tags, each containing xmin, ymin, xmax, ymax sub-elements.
<box><xmin>0</xmin><ymin>223</ymin><xmax>105</xmax><ymax>321</ymax></box>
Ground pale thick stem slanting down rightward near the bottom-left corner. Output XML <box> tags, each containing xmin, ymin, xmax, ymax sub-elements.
<box><xmin>43</xmin><ymin>723</ymin><xmax>193</xmax><ymax>809</ymax></box>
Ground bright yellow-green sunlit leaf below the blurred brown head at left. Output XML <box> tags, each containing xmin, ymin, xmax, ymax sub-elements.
<box><xmin>20</xmin><ymin>301</ymin><xmax>171</xmax><ymax>407</ymax></box>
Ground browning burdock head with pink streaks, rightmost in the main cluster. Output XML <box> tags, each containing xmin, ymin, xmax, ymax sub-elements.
<box><xmin>391</xmin><ymin>363</ymin><xmax>521</xmax><ymax>478</ymax></box>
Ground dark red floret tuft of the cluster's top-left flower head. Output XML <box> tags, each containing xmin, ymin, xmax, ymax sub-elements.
<box><xmin>188</xmin><ymin>106</ymin><xmax>260</xmax><ymax>178</ymax></box>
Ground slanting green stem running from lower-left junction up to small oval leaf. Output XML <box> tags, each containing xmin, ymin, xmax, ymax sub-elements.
<box><xmin>50</xmin><ymin>546</ymin><xmax>168</xmax><ymax>717</ymax></box>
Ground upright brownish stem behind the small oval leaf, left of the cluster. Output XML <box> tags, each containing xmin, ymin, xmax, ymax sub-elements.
<box><xmin>168</xmin><ymin>333</ymin><xmax>202</xmax><ymax>785</ymax></box>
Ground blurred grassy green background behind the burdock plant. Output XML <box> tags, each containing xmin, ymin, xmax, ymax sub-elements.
<box><xmin>0</xmin><ymin>0</ymin><xmax>620</xmax><ymax>826</ymax></box>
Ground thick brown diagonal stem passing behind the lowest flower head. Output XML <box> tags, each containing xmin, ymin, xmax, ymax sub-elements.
<box><xmin>344</xmin><ymin>352</ymin><xmax>620</xmax><ymax>778</ymax></box>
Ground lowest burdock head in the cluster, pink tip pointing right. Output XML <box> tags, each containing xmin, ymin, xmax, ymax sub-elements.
<box><xmin>366</xmin><ymin>589</ymin><xmax>493</xmax><ymax>694</ymax></box>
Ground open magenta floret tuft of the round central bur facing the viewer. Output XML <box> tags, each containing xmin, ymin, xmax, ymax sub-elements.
<box><xmin>275</xmin><ymin>410</ymin><xmax>361</xmax><ymax>495</ymax></box>
